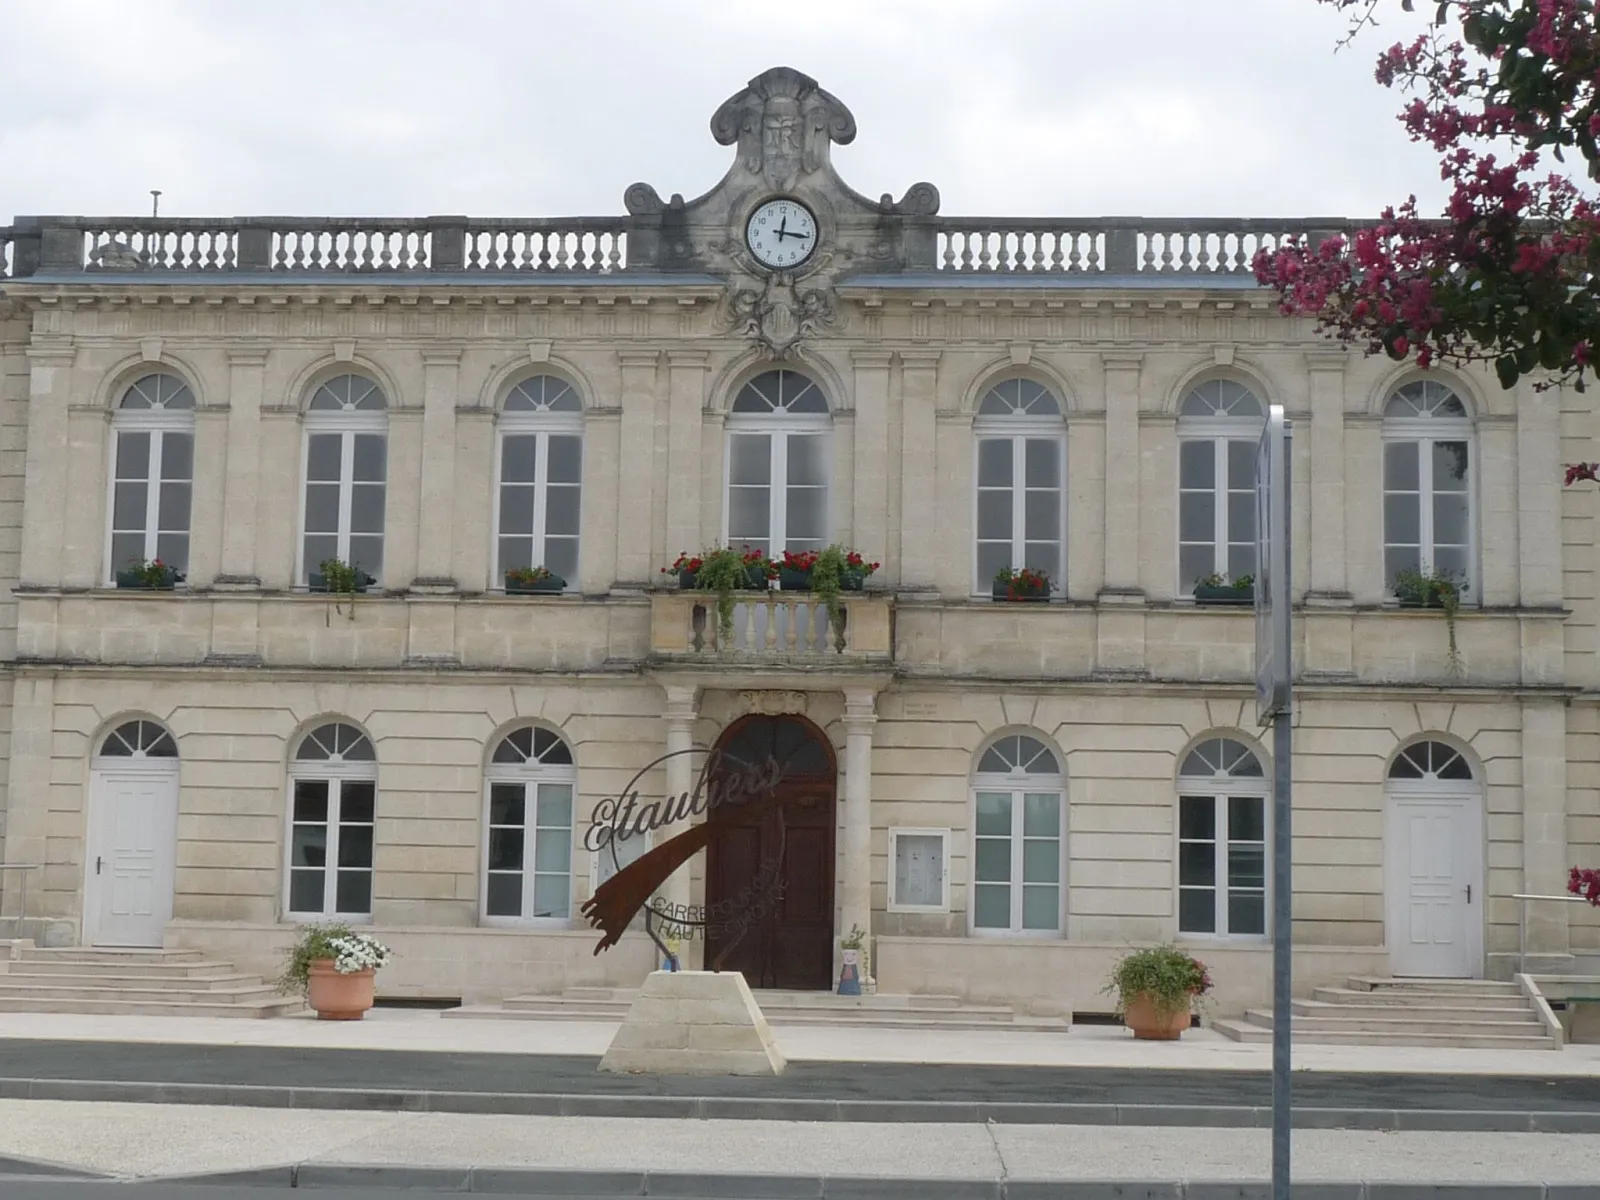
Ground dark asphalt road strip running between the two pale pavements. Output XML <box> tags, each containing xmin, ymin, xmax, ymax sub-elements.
<box><xmin>0</xmin><ymin>1040</ymin><xmax>1600</xmax><ymax>1113</ymax></box>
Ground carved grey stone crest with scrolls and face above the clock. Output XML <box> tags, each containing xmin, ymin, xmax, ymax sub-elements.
<box><xmin>710</xmin><ymin>67</ymin><xmax>856</xmax><ymax>192</ymax></box>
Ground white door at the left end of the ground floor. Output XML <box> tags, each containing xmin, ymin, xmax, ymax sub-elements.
<box><xmin>83</xmin><ymin>763</ymin><xmax>178</xmax><ymax>947</ymax></box>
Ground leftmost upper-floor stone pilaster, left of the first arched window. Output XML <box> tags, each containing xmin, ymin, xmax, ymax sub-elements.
<box><xmin>21</xmin><ymin>345</ymin><xmax>75</xmax><ymax>587</ymax></box>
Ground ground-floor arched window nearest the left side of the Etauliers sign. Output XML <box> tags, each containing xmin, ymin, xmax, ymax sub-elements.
<box><xmin>483</xmin><ymin>726</ymin><xmax>579</xmax><ymax>923</ymax></box>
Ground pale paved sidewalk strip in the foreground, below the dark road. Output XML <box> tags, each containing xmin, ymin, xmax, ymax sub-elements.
<box><xmin>0</xmin><ymin>1101</ymin><xmax>1600</xmax><ymax>1195</ymax></box>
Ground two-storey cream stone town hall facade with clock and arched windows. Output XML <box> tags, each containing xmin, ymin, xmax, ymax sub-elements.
<box><xmin>0</xmin><ymin>69</ymin><xmax>1600</xmax><ymax>1011</ymax></box>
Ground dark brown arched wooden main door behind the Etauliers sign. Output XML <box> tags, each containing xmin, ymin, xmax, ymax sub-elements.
<box><xmin>706</xmin><ymin>715</ymin><xmax>838</xmax><ymax>990</ymax></box>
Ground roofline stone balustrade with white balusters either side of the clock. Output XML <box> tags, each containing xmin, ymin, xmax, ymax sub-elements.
<box><xmin>0</xmin><ymin>214</ymin><xmax>1363</xmax><ymax>278</ymax></box>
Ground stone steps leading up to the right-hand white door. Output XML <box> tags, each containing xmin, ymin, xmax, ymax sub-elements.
<box><xmin>1211</xmin><ymin>976</ymin><xmax>1560</xmax><ymax>1050</ymax></box>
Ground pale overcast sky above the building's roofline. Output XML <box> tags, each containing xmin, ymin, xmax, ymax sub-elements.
<box><xmin>0</xmin><ymin>0</ymin><xmax>1443</xmax><ymax>218</ymax></box>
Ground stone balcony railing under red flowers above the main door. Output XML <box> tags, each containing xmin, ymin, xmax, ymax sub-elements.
<box><xmin>650</xmin><ymin>592</ymin><xmax>894</xmax><ymax>664</ymax></box>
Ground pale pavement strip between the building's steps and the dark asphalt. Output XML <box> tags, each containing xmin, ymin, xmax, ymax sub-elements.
<box><xmin>0</xmin><ymin>1008</ymin><xmax>1600</xmax><ymax>1077</ymax></box>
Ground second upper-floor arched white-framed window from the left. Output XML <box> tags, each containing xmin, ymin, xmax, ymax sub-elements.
<box><xmin>299</xmin><ymin>374</ymin><xmax>389</xmax><ymax>581</ymax></box>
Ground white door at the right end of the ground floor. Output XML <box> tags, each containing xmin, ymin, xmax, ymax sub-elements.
<box><xmin>1386</xmin><ymin>794</ymin><xmax>1483</xmax><ymax>979</ymax></box>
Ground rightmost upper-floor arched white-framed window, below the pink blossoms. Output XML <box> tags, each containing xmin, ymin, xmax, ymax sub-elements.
<box><xmin>1384</xmin><ymin>379</ymin><xmax>1477</xmax><ymax>600</ymax></box>
